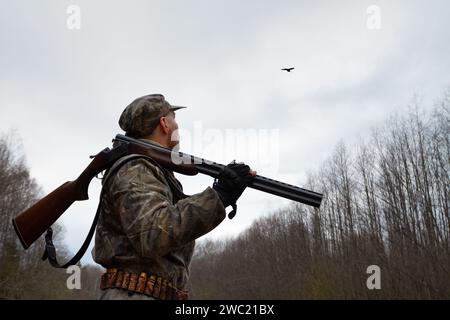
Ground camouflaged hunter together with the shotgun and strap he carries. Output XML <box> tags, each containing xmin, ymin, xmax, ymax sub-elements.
<box><xmin>12</xmin><ymin>94</ymin><xmax>323</xmax><ymax>300</ymax></box>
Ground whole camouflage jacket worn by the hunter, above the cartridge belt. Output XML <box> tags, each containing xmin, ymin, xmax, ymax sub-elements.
<box><xmin>92</xmin><ymin>141</ymin><xmax>225</xmax><ymax>290</ymax></box>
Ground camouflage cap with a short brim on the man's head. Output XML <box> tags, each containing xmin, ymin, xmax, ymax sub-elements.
<box><xmin>119</xmin><ymin>94</ymin><xmax>186</xmax><ymax>137</ymax></box>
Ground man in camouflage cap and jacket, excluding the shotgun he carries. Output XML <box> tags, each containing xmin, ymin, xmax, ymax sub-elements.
<box><xmin>92</xmin><ymin>94</ymin><xmax>256</xmax><ymax>300</ymax></box>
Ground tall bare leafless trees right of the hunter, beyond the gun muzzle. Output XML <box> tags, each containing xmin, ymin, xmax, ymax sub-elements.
<box><xmin>191</xmin><ymin>92</ymin><xmax>450</xmax><ymax>299</ymax></box>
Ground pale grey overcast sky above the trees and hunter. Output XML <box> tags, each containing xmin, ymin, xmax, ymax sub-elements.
<box><xmin>0</xmin><ymin>0</ymin><xmax>450</xmax><ymax>261</ymax></box>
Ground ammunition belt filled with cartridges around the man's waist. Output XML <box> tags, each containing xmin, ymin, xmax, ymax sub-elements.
<box><xmin>100</xmin><ymin>269</ymin><xmax>188</xmax><ymax>300</ymax></box>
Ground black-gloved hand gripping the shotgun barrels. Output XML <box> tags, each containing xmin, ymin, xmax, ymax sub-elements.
<box><xmin>213</xmin><ymin>161</ymin><xmax>256</xmax><ymax>218</ymax></box>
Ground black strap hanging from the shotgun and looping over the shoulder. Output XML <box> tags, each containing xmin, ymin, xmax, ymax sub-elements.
<box><xmin>42</xmin><ymin>154</ymin><xmax>187</xmax><ymax>269</ymax></box>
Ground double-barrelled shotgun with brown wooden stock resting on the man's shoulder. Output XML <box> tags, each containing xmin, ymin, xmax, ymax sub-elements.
<box><xmin>12</xmin><ymin>134</ymin><xmax>322</xmax><ymax>249</ymax></box>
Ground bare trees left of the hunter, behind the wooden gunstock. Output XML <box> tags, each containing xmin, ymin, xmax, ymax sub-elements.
<box><xmin>0</xmin><ymin>135</ymin><xmax>101</xmax><ymax>299</ymax></box>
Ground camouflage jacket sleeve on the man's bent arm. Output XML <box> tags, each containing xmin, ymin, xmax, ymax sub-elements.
<box><xmin>112</xmin><ymin>159</ymin><xmax>225</xmax><ymax>257</ymax></box>
